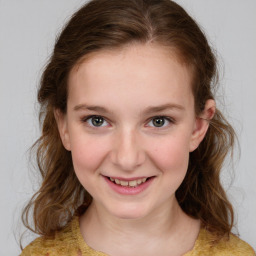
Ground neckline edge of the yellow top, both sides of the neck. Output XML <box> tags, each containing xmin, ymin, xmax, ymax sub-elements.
<box><xmin>71</xmin><ymin>216</ymin><xmax>205</xmax><ymax>256</ymax></box>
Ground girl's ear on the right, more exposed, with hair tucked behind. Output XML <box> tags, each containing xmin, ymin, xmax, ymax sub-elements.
<box><xmin>189</xmin><ymin>99</ymin><xmax>216</xmax><ymax>152</ymax></box>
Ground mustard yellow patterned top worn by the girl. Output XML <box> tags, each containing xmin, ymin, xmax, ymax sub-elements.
<box><xmin>21</xmin><ymin>217</ymin><xmax>256</xmax><ymax>256</ymax></box>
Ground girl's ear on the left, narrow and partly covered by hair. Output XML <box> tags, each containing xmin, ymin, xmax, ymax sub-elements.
<box><xmin>54</xmin><ymin>109</ymin><xmax>70</xmax><ymax>151</ymax></box>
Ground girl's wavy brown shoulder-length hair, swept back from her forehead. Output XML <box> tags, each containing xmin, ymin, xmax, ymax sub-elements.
<box><xmin>22</xmin><ymin>0</ymin><xmax>235</xmax><ymax>245</ymax></box>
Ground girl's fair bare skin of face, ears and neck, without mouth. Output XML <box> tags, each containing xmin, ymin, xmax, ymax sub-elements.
<box><xmin>55</xmin><ymin>44</ymin><xmax>215</xmax><ymax>256</ymax></box>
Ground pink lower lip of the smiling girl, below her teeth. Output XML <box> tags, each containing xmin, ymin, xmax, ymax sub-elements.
<box><xmin>104</xmin><ymin>177</ymin><xmax>154</xmax><ymax>195</ymax></box>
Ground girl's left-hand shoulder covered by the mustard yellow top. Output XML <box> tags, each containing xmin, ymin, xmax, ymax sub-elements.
<box><xmin>20</xmin><ymin>219</ymin><xmax>80</xmax><ymax>256</ymax></box>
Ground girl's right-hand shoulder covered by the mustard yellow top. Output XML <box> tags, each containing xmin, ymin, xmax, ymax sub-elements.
<box><xmin>192</xmin><ymin>230</ymin><xmax>256</xmax><ymax>256</ymax></box>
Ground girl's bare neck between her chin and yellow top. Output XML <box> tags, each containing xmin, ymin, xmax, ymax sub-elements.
<box><xmin>80</xmin><ymin>198</ymin><xmax>198</xmax><ymax>255</ymax></box>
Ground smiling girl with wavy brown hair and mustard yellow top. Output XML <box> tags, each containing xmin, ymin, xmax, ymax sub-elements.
<box><xmin>21</xmin><ymin>0</ymin><xmax>254</xmax><ymax>256</ymax></box>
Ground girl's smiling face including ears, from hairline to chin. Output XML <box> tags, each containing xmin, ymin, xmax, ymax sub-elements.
<box><xmin>57</xmin><ymin>45</ymin><xmax>213</xmax><ymax>219</ymax></box>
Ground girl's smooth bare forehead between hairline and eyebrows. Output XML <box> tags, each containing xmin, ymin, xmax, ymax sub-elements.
<box><xmin>68</xmin><ymin>44</ymin><xmax>192</xmax><ymax>111</ymax></box>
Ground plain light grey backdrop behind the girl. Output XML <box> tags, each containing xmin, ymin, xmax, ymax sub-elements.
<box><xmin>0</xmin><ymin>0</ymin><xmax>256</xmax><ymax>256</ymax></box>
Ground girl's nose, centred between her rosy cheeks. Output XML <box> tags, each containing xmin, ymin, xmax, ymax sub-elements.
<box><xmin>111</xmin><ymin>129</ymin><xmax>146</xmax><ymax>171</ymax></box>
